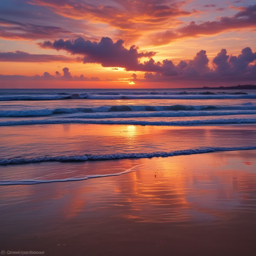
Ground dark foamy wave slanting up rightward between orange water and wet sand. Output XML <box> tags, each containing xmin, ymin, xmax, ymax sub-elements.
<box><xmin>0</xmin><ymin>146</ymin><xmax>256</xmax><ymax>168</ymax></box>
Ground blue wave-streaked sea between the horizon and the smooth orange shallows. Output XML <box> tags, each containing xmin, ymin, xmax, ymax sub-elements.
<box><xmin>0</xmin><ymin>89</ymin><xmax>256</xmax><ymax>126</ymax></box>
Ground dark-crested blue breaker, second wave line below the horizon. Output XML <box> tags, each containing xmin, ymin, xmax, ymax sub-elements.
<box><xmin>0</xmin><ymin>103</ymin><xmax>256</xmax><ymax>118</ymax></box>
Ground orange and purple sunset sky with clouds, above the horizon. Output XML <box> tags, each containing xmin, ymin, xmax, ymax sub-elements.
<box><xmin>0</xmin><ymin>0</ymin><xmax>256</xmax><ymax>88</ymax></box>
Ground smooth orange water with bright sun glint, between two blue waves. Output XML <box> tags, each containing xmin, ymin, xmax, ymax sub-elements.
<box><xmin>0</xmin><ymin>124</ymin><xmax>256</xmax><ymax>159</ymax></box>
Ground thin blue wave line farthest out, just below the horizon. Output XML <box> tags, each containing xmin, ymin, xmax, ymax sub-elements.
<box><xmin>0</xmin><ymin>92</ymin><xmax>256</xmax><ymax>101</ymax></box>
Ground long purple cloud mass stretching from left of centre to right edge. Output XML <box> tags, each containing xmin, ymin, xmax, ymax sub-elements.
<box><xmin>39</xmin><ymin>37</ymin><xmax>256</xmax><ymax>79</ymax></box>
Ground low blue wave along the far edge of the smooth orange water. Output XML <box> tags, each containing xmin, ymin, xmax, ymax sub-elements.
<box><xmin>0</xmin><ymin>118</ymin><xmax>256</xmax><ymax>126</ymax></box>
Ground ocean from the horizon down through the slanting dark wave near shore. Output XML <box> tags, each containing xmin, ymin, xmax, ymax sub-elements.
<box><xmin>0</xmin><ymin>89</ymin><xmax>256</xmax><ymax>178</ymax></box>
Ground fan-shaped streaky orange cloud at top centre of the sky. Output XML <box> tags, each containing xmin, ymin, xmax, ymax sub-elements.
<box><xmin>28</xmin><ymin>0</ymin><xmax>200</xmax><ymax>44</ymax></box>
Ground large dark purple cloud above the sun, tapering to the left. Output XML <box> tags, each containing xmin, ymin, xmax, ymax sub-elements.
<box><xmin>39</xmin><ymin>37</ymin><xmax>156</xmax><ymax>71</ymax></box>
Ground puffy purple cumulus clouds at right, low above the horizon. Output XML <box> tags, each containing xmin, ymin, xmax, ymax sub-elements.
<box><xmin>144</xmin><ymin>47</ymin><xmax>256</xmax><ymax>81</ymax></box>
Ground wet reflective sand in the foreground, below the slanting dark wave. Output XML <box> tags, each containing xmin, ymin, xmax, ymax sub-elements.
<box><xmin>0</xmin><ymin>150</ymin><xmax>256</xmax><ymax>256</ymax></box>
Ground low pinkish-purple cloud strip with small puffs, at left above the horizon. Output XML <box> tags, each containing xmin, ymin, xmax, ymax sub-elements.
<box><xmin>0</xmin><ymin>67</ymin><xmax>100</xmax><ymax>81</ymax></box>
